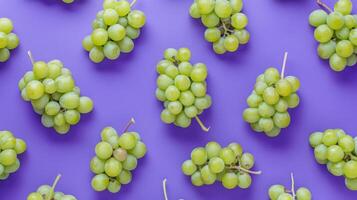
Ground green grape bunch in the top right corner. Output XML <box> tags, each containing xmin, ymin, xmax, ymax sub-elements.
<box><xmin>309</xmin><ymin>0</ymin><xmax>357</xmax><ymax>72</ymax></box>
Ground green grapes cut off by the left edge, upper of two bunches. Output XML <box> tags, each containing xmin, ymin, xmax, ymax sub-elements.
<box><xmin>0</xmin><ymin>18</ymin><xmax>19</xmax><ymax>63</ymax></box>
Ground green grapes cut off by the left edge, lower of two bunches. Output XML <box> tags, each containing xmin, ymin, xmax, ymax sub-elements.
<box><xmin>0</xmin><ymin>131</ymin><xmax>27</xmax><ymax>180</ymax></box>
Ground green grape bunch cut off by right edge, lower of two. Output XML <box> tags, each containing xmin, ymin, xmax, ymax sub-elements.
<box><xmin>309</xmin><ymin>129</ymin><xmax>357</xmax><ymax>190</ymax></box>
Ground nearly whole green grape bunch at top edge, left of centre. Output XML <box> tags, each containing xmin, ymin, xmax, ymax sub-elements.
<box><xmin>82</xmin><ymin>0</ymin><xmax>146</xmax><ymax>63</ymax></box>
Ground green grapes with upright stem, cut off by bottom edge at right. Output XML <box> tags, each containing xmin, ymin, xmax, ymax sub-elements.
<box><xmin>268</xmin><ymin>174</ymin><xmax>312</xmax><ymax>200</ymax></box>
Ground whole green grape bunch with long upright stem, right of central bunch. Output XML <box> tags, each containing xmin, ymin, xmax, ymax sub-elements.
<box><xmin>243</xmin><ymin>53</ymin><xmax>300</xmax><ymax>137</ymax></box>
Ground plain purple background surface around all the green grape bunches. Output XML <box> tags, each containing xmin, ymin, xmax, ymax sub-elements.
<box><xmin>0</xmin><ymin>0</ymin><xmax>357</xmax><ymax>200</ymax></box>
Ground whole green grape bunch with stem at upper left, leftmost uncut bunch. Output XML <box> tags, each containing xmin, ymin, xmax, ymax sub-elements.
<box><xmin>19</xmin><ymin>52</ymin><xmax>93</xmax><ymax>134</ymax></box>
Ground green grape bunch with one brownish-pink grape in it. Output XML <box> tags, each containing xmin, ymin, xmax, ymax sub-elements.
<box><xmin>90</xmin><ymin>119</ymin><xmax>146</xmax><ymax>193</ymax></box>
